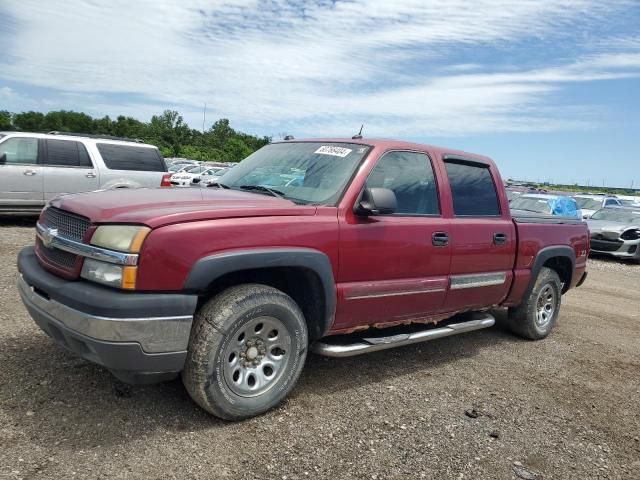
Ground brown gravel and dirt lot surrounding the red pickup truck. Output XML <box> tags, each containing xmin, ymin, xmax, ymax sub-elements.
<box><xmin>0</xmin><ymin>220</ymin><xmax>640</xmax><ymax>479</ymax></box>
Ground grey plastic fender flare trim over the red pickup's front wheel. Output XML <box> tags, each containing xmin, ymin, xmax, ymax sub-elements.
<box><xmin>183</xmin><ymin>248</ymin><xmax>337</xmax><ymax>336</ymax></box>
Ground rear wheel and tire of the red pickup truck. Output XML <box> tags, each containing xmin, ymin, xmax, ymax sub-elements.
<box><xmin>507</xmin><ymin>267</ymin><xmax>562</xmax><ymax>340</ymax></box>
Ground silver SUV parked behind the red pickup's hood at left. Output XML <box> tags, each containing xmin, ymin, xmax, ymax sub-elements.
<box><xmin>0</xmin><ymin>132</ymin><xmax>170</xmax><ymax>213</ymax></box>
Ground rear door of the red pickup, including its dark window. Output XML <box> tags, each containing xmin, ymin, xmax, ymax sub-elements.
<box><xmin>444</xmin><ymin>155</ymin><xmax>516</xmax><ymax>311</ymax></box>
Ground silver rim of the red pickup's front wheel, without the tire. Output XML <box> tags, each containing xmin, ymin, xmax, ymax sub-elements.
<box><xmin>222</xmin><ymin>317</ymin><xmax>291</xmax><ymax>397</ymax></box>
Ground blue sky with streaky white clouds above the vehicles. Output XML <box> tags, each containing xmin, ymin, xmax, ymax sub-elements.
<box><xmin>0</xmin><ymin>0</ymin><xmax>640</xmax><ymax>187</ymax></box>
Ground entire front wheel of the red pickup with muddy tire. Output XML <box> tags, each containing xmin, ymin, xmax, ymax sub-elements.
<box><xmin>182</xmin><ymin>284</ymin><xmax>308</xmax><ymax>420</ymax></box>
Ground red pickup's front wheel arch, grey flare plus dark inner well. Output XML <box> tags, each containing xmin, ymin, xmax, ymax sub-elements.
<box><xmin>184</xmin><ymin>248</ymin><xmax>336</xmax><ymax>342</ymax></box>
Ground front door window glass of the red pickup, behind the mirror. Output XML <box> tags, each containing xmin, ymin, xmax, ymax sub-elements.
<box><xmin>366</xmin><ymin>152</ymin><xmax>440</xmax><ymax>215</ymax></box>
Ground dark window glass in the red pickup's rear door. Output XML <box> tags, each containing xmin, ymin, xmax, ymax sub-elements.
<box><xmin>445</xmin><ymin>161</ymin><xmax>500</xmax><ymax>217</ymax></box>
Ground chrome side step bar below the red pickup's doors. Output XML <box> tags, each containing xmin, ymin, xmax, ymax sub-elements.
<box><xmin>311</xmin><ymin>313</ymin><xmax>496</xmax><ymax>357</ymax></box>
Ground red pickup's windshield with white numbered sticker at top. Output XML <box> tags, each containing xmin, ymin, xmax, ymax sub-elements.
<box><xmin>220</xmin><ymin>142</ymin><xmax>370</xmax><ymax>205</ymax></box>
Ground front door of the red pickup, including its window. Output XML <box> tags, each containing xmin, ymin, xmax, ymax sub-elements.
<box><xmin>334</xmin><ymin>151</ymin><xmax>451</xmax><ymax>330</ymax></box>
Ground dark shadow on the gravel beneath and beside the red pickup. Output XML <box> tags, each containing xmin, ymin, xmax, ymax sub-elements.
<box><xmin>0</xmin><ymin>312</ymin><xmax>523</xmax><ymax>450</ymax></box>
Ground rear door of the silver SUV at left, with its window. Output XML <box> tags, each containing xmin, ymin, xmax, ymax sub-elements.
<box><xmin>43</xmin><ymin>139</ymin><xmax>99</xmax><ymax>200</ymax></box>
